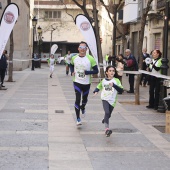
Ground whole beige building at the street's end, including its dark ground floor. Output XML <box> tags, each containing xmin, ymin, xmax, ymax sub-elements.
<box><xmin>34</xmin><ymin>0</ymin><xmax>112</xmax><ymax>57</ymax></box>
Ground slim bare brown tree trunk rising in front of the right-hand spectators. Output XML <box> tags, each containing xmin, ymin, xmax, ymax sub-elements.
<box><xmin>135</xmin><ymin>0</ymin><xmax>153</xmax><ymax>105</ymax></box>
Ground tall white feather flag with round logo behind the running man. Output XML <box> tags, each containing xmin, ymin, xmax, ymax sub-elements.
<box><xmin>75</xmin><ymin>14</ymin><xmax>98</xmax><ymax>65</ymax></box>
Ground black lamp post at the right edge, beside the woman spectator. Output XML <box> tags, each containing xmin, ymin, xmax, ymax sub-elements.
<box><xmin>158</xmin><ymin>1</ymin><xmax>170</xmax><ymax>113</ymax></box>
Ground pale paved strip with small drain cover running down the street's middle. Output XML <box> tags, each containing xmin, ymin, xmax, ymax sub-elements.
<box><xmin>48</xmin><ymin>74</ymin><xmax>93</xmax><ymax>170</ymax></box>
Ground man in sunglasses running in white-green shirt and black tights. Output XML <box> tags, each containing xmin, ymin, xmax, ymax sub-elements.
<box><xmin>70</xmin><ymin>41</ymin><xmax>98</xmax><ymax>125</ymax></box>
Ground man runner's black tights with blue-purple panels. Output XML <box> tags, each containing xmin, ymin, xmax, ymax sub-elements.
<box><xmin>73</xmin><ymin>82</ymin><xmax>90</xmax><ymax>119</ymax></box>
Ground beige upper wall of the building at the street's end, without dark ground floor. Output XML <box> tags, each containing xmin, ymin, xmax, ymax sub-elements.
<box><xmin>35</xmin><ymin>0</ymin><xmax>112</xmax><ymax>59</ymax></box>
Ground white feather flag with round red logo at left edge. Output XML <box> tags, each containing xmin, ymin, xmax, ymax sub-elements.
<box><xmin>0</xmin><ymin>3</ymin><xmax>19</xmax><ymax>58</ymax></box>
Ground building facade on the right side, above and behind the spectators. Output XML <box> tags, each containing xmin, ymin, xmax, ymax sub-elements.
<box><xmin>123</xmin><ymin>0</ymin><xmax>170</xmax><ymax>70</ymax></box>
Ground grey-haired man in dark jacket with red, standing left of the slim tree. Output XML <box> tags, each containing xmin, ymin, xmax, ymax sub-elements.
<box><xmin>125</xmin><ymin>49</ymin><xmax>138</xmax><ymax>93</ymax></box>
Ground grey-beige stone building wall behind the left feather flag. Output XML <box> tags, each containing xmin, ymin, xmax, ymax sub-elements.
<box><xmin>0</xmin><ymin>0</ymin><xmax>30</xmax><ymax>70</ymax></box>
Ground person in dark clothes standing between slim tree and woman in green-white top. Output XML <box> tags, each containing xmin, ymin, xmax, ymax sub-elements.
<box><xmin>140</xmin><ymin>48</ymin><xmax>150</xmax><ymax>87</ymax></box>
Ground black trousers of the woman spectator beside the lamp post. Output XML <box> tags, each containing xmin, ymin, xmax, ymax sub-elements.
<box><xmin>149</xmin><ymin>76</ymin><xmax>161</xmax><ymax>109</ymax></box>
